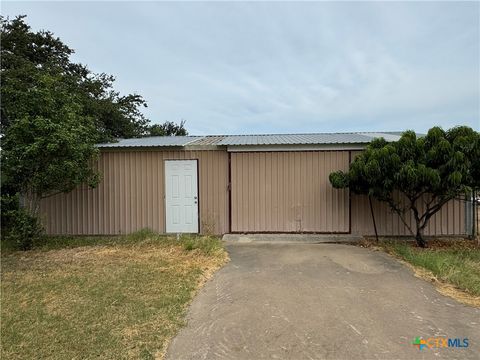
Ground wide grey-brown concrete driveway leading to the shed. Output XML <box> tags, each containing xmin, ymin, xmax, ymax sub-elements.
<box><xmin>167</xmin><ymin>243</ymin><xmax>480</xmax><ymax>359</ymax></box>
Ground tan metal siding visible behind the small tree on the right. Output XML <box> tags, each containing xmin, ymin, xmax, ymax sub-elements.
<box><xmin>351</xmin><ymin>151</ymin><xmax>465</xmax><ymax>236</ymax></box>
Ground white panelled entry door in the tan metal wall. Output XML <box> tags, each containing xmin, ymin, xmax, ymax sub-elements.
<box><xmin>165</xmin><ymin>160</ymin><xmax>198</xmax><ymax>233</ymax></box>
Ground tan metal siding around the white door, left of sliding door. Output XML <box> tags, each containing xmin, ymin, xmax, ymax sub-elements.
<box><xmin>41</xmin><ymin>150</ymin><xmax>228</xmax><ymax>235</ymax></box>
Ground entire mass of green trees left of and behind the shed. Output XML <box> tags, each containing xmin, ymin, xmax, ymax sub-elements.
<box><xmin>0</xmin><ymin>16</ymin><xmax>190</xmax><ymax>247</ymax></box>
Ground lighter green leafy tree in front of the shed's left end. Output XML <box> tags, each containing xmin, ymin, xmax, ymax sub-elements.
<box><xmin>2</xmin><ymin>74</ymin><xmax>99</xmax><ymax>217</ymax></box>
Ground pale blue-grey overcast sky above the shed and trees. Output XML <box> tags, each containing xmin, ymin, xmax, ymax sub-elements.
<box><xmin>2</xmin><ymin>2</ymin><xmax>480</xmax><ymax>135</ymax></box>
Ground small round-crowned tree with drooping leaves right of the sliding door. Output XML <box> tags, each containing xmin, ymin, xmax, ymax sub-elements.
<box><xmin>330</xmin><ymin>126</ymin><xmax>480</xmax><ymax>247</ymax></box>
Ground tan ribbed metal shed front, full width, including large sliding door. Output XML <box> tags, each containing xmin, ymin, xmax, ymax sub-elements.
<box><xmin>41</xmin><ymin>146</ymin><xmax>466</xmax><ymax>235</ymax></box>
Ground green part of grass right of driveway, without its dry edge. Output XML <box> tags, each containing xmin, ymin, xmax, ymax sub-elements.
<box><xmin>381</xmin><ymin>240</ymin><xmax>480</xmax><ymax>296</ymax></box>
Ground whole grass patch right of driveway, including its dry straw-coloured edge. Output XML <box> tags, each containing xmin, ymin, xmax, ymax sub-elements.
<box><xmin>360</xmin><ymin>238</ymin><xmax>480</xmax><ymax>307</ymax></box>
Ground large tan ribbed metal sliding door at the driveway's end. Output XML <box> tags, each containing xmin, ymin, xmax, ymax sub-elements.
<box><xmin>231</xmin><ymin>151</ymin><xmax>349</xmax><ymax>233</ymax></box>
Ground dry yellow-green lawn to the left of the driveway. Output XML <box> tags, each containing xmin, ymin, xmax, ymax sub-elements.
<box><xmin>1</xmin><ymin>231</ymin><xmax>228</xmax><ymax>359</ymax></box>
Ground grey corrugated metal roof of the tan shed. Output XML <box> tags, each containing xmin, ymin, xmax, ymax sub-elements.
<box><xmin>97</xmin><ymin>132</ymin><xmax>401</xmax><ymax>148</ymax></box>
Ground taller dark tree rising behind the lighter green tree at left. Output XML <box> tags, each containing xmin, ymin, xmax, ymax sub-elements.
<box><xmin>0</xmin><ymin>16</ymin><xmax>149</xmax><ymax>142</ymax></box>
